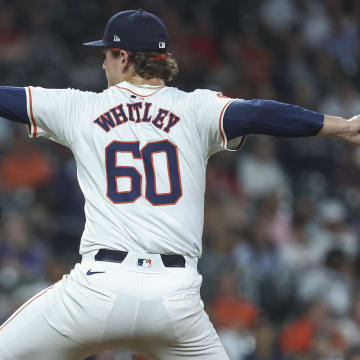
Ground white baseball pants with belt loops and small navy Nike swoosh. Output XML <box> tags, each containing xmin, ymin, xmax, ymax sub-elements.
<box><xmin>0</xmin><ymin>252</ymin><xmax>229</xmax><ymax>360</ymax></box>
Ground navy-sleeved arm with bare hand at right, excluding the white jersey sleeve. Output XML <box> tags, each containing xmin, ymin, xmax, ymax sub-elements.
<box><xmin>223</xmin><ymin>99</ymin><xmax>360</xmax><ymax>144</ymax></box>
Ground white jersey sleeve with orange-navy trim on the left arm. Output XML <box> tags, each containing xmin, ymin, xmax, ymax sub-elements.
<box><xmin>26</xmin><ymin>86</ymin><xmax>95</xmax><ymax>148</ymax></box>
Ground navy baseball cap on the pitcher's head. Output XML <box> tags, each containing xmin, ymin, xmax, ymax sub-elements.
<box><xmin>84</xmin><ymin>9</ymin><xmax>169</xmax><ymax>53</ymax></box>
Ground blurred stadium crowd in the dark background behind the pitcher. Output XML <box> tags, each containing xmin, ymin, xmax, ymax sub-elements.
<box><xmin>0</xmin><ymin>0</ymin><xmax>360</xmax><ymax>360</ymax></box>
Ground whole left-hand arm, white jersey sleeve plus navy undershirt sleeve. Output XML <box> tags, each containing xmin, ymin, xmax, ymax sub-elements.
<box><xmin>0</xmin><ymin>86</ymin><xmax>96</xmax><ymax>148</ymax></box>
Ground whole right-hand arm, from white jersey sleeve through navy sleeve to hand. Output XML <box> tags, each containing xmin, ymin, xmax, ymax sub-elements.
<box><xmin>192</xmin><ymin>90</ymin><xmax>360</xmax><ymax>157</ymax></box>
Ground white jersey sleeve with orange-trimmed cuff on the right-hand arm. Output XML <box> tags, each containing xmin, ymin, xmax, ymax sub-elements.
<box><xmin>193</xmin><ymin>89</ymin><xmax>245</xmax><ymax>156</ymax></box>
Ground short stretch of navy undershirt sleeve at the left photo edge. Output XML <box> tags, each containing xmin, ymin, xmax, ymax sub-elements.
<box><xmin>0</xmin><ymin>86</ymin><xmax>29</xmax><ymax>125</ymax></box>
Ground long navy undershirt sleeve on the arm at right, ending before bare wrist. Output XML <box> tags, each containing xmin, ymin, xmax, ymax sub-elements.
<box><xmin>223</xmin><ymin>99</ymin><xmax>324</xmax><ymax>140</ymax></box>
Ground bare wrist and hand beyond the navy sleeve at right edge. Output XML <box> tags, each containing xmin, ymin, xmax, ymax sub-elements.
<box><xmin>318</xmin><ymin>115</ymin><xmax>360</xmax><ymax>145</ymax></box>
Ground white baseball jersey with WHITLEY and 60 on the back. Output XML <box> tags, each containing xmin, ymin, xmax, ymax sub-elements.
<box><xmin>26</xmin><ymin>82</ymin><xmax>243</xmax><ymax>257</ymax></box>
